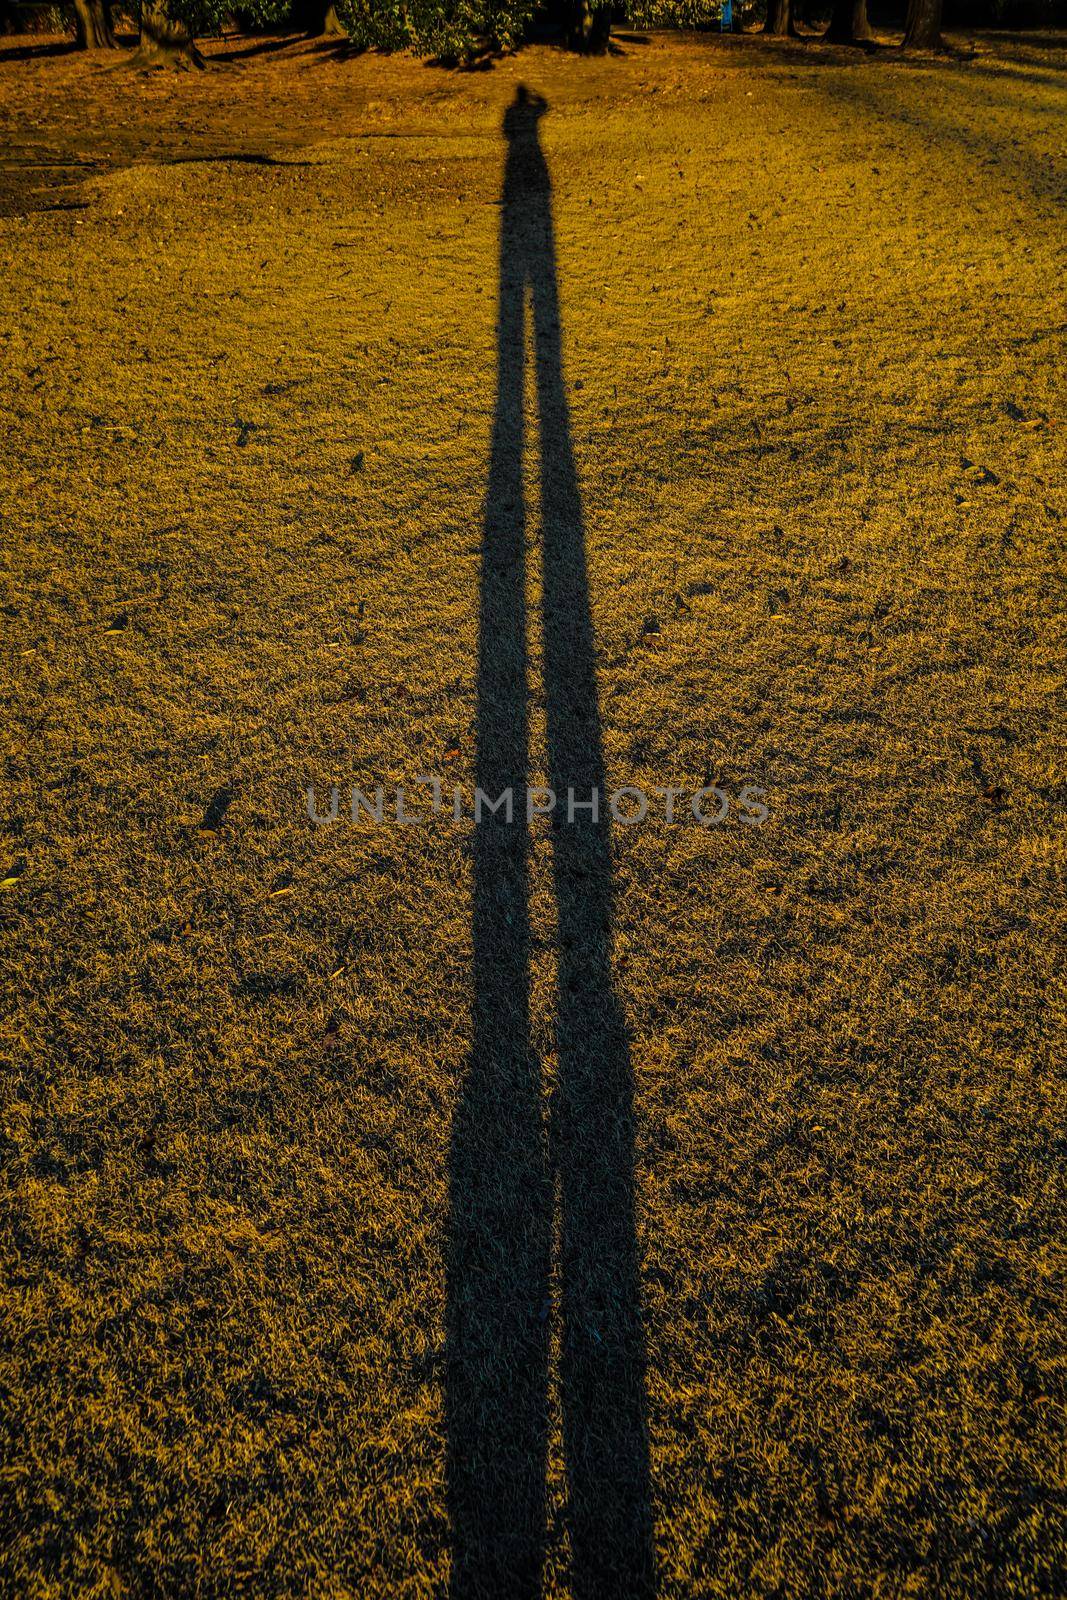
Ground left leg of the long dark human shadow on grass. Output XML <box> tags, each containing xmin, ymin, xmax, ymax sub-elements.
<box><xmin>446</xmin><ymin>90</ymin><xmax>552</xmax><ymax>1600</ymax></box>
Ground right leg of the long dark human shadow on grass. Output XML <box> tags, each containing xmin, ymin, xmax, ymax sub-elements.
<box><xmin>530</xmin><ymin>106</ymin><xmax>653</xmax><ymax>1600</ymax></box>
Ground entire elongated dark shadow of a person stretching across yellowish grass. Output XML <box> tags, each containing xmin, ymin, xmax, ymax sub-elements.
<box><xmin>446</xmin><ymin>88</ymin><xmax>654</xmax><ymax>1600</ymax></box>
